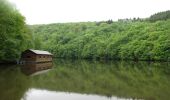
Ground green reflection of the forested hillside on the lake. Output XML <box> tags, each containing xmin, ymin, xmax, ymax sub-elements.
<box><xmin>29</xmin><ymin>60</ymin><xmax>170</xmax><ymax>100</ymax></box>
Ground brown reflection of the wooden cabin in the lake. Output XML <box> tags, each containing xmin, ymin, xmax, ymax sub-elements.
<box><xmin>21</xmin><ymin>62</ymin><xmax>53</xmax><ymax>75</ymax></box>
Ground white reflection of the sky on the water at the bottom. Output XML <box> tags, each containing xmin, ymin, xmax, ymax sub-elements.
<box><xmin>21</xmin><ymin>89</ymin><xmax>129</xmax><ymax>100</ymax></box>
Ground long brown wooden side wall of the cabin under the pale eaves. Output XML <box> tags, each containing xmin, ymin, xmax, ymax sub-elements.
<box><xmin>36</xmin><ymin>55</ymin><xmax>52</xmax><ymax>62</ymax></box>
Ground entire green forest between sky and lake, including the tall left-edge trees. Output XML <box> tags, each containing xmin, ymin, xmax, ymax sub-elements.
<box><xmin>0</xmin><ymin>0</ymin><xmax>170</xmax><ymax>63</ymax></box>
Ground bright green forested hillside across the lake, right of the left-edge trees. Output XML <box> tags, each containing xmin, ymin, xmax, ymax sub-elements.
<box><xmin>30</xmin><ymin>15</ymin><xmax>170</xmax><ymax>61</ymax></box>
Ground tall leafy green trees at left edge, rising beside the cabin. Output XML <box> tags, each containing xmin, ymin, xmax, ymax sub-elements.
<box><xmin>0</xmin><ymin>0</ymin><xmax>33</xmax><ymax>63</ymax></box>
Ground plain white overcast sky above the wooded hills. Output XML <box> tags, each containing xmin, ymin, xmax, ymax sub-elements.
<box><xmin>9</xmin><ymin>0</ymin><xmax>170</xmax><ymax>25</ymax></box>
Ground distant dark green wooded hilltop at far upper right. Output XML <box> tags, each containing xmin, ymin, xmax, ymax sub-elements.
<box><xmin>149</xmin><ymin>10</ymin><xmax>170</xmax><ymax>22</ymax></box>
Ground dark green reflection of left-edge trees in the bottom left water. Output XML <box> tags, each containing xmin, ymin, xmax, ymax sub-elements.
<box><xmin>0</xmin><ymin>65</ymin><xmax>30</xmax><ymax>100</ymax></box>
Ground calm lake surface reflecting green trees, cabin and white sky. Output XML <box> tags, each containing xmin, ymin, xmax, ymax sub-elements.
<box><xmin>0</xmin><ymin>60</ymin><xmax>170</xmax><ymax>100</ymax></box>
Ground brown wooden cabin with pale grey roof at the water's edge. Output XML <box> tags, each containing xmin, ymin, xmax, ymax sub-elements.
<box><xmin>21</xmin><ymin>49</ymin><xmax>52</xmax><ymax>63</ymax></box>
